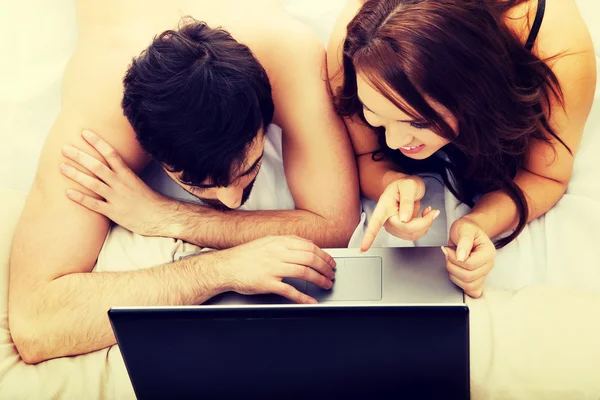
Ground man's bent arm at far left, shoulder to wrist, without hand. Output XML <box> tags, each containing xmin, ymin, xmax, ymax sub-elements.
<box><xmin>8</xmin><ymin>49</ymin><xmax>220</xmax><ymax>363</ymax></box>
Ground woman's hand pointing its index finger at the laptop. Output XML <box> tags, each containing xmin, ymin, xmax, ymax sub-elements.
<box><xmin>360</xmin><ymin>176</ymin><xmax>440</xmax><ymax>251</ymax></box>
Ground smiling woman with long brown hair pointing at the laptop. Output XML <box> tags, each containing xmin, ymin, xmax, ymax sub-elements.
<box><xmin>328</xmin><ymin>0</ymin><xmax>596</xmax><ymax>297</ymax></box>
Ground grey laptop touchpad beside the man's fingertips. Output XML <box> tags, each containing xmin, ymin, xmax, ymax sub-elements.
<box><xmin>306</xmin><ymin>257</ymin><xmax>381</xmax><ymax>302</ymax></box>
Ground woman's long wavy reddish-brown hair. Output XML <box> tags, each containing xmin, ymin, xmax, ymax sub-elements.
<box><xmin>335</xmin><ymin>0</ymin><xmax>570</xmax><ymax>248</ymax></box>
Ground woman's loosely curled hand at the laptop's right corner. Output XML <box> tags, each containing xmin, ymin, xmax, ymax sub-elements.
<box><xmin>442</xmin><ymin>217</ymin><xmax>496</xmax><ymax>298</ymax></box>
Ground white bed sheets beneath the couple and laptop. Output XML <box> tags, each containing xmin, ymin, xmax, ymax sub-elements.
<box><xmin>0</xmin><ymin>0</ymin><xmax>600</xmax><ymax>399</ymax></box>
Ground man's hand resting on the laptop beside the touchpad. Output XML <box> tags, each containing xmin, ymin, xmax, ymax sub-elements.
<box><xmin>220</xmin><ymin>236</ymin><xmax>336</xmax><ymax>304</ymax></box>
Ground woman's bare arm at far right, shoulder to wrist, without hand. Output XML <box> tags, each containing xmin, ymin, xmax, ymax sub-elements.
<box><xmin>468</xmin><ymin>2</ymin><xmax>596</xmax><ymax>237</ymax></box>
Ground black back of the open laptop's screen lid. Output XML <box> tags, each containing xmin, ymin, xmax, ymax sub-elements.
<box><xmin>109</xmin><ymin>305</ymin><xmax>469</xmax><ymax>399</ymax></box>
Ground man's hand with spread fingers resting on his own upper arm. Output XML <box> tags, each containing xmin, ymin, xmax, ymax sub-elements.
<box><xmin>60</xmin><ymin>131</ymin><xmax>173</xmax><ymax>236</ymax></box>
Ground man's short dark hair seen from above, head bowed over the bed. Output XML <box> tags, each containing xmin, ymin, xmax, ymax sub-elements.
<box><xmin>121</xmin><ymin>18</ymin><xmax>274</xmax><ymax>186</ymax></box>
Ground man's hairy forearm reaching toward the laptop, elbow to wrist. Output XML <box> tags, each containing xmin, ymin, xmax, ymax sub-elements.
<box><xmin>10</xmin><ymin>247</ymin><xmax>226</xmax><ymax>364</ymax></box>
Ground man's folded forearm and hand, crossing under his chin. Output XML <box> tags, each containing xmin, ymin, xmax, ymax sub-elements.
<box><xmin>56</xmin><ymin>126</ymin><xmax>356</xmax><ymax>248</ymax></box>
